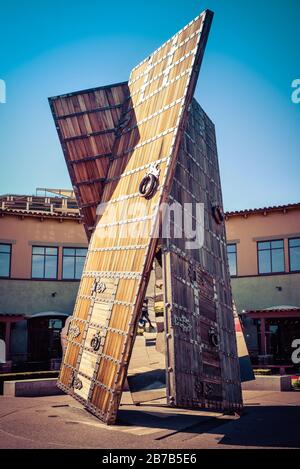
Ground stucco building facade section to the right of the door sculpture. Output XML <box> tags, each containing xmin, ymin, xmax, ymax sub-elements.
<box><xmin>226</xmin><ymin>203</ymin><xmax>300</xmax><ymax>368</ymax></box>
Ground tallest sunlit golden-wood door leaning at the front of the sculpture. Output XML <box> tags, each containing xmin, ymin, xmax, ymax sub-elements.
<box><xmin>52</xmin><ymin>11</ymin><xmax>216</xmax><ymax>423</ymax></box>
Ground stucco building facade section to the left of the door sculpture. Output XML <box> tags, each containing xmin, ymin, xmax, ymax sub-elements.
<box><xmin>0</xmin><ymin>194</ymin><xmax>87</xmax><ymax>370</ymax></box>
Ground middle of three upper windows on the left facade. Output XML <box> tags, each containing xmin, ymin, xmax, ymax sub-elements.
<box><xmin>31</xmin><ymin>246</ymin><xmax>58</xmax><ymax>279</ymax></box>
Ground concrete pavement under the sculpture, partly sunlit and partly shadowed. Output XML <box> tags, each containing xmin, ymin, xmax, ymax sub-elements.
<box><xmin>0</xmin><ymin>391</ymin><xmax>300</xmax><ymax>449</ymax></box>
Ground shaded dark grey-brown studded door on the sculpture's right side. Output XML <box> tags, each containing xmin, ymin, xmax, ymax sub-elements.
<box><xmin>162</xmin><ymin>100</ymin><xmax>242</xmax><ymax>412</ymax></box>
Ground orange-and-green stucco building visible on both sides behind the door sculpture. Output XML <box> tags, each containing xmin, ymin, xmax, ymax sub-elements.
<box><xmin>0</xmin><ymin>191</ymin><xmax>300</xmax><ymax>370</ymax></box>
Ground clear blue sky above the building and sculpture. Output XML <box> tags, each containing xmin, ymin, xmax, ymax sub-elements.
<box><xmin>0</xmin><ymin>0</ymin><xmax>300</xmax><ymax>210</ymax></box>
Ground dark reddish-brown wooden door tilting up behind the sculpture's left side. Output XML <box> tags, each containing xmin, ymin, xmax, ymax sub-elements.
<box><xmin>49</xmin><ymin>83</ymin><xmax>129</xmax><ymax>238</ymax></box>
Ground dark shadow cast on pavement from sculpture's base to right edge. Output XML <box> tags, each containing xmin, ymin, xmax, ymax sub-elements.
<box><xmin>117</xmin><ymin>405</ymin><xmax>300</xmax><ymax>448</ymax></box>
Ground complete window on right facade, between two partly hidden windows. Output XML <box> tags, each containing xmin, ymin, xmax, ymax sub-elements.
<box><xmin>257</xmin><ymin>239</ymin><xmax>284</xmax><ymax>274</ymax></box>
